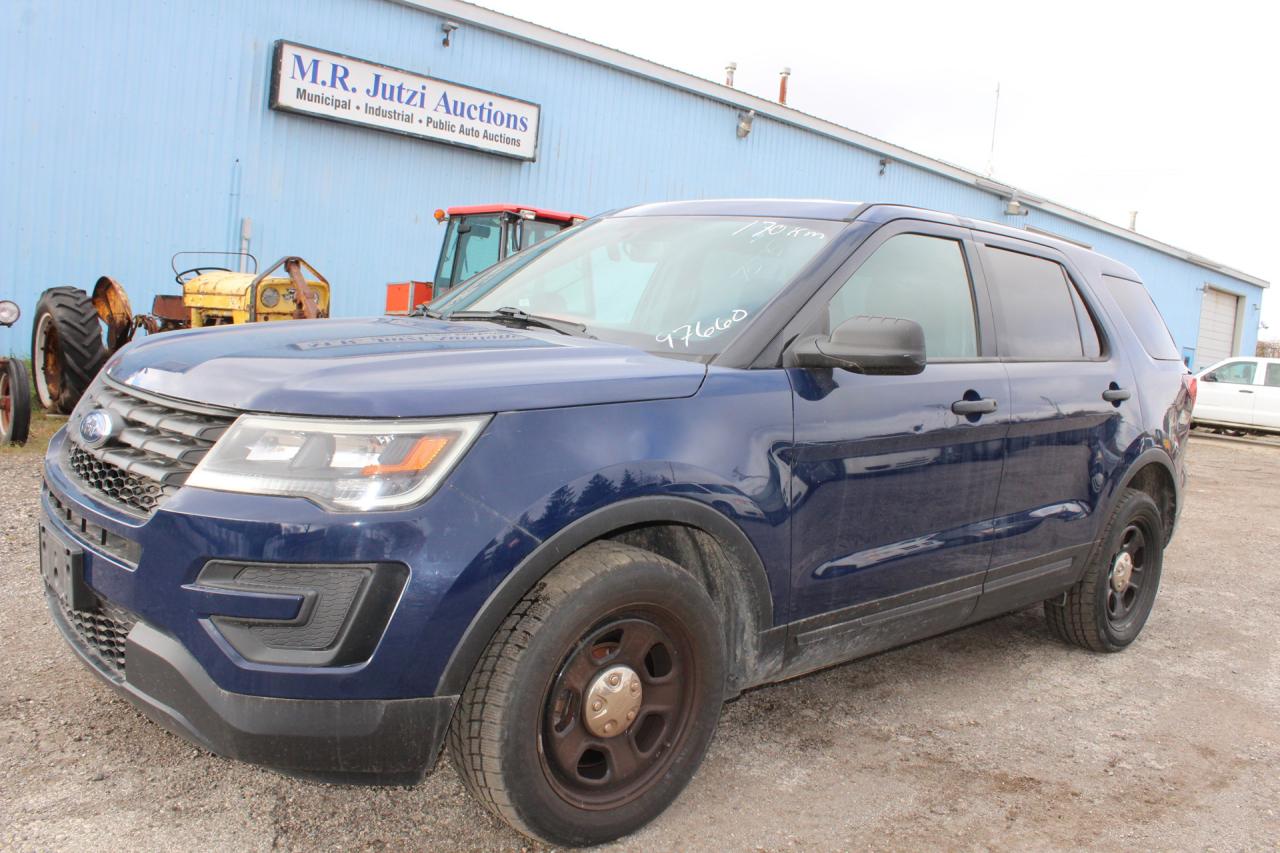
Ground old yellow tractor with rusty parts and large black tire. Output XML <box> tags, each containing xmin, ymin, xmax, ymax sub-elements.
<box><xmin>31</xmin><ymin>252</ymin><xmax>330</xmax><ymax>414</ymax></box>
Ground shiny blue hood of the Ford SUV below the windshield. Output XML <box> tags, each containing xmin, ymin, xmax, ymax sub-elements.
<box><xmin>106</xmin><ymin>318</ymin><xmax>707</xmax><ymax>418</ymax></box>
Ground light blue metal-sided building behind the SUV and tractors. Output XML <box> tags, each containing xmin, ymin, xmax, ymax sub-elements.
<box><xmin>0</xmin><ymin>0</ymin><xmax>1267</xmax><ymax>366</ymax></box>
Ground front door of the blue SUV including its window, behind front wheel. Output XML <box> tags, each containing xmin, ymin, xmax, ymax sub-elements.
<box><xmin>787</xmin><ymin>222</ymin><xmax>1009</xmax><ymax>655</ymax></box>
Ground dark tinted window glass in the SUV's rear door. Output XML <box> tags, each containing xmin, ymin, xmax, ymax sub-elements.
<box><xmin>982</xmin><ymin>246</ymin><xmax>1102</xmax><ymax>361</ymax></box>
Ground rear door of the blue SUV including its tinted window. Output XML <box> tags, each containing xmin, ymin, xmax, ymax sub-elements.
<box><xmin>974</xmin><ymin>232</ymin><xmax>1140</xmax><ymax>616</ymax></box>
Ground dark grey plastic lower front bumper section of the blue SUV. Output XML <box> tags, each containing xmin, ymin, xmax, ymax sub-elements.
<box><xmin>46</xmin><ymin>589</ymin><xmax>457</xmax><ymax>784</ymax></box>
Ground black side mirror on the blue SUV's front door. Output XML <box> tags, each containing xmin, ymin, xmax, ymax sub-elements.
<box><xmin>787</xmin><ymin>316</ymin><xmax>924</xmax><ymax>377</ymax></box>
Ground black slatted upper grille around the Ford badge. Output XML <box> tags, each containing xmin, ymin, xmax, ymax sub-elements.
<box><xmin>67</xmin><ymin>379</ymin><xmax>234</xmax><ymax>515</ymax></box>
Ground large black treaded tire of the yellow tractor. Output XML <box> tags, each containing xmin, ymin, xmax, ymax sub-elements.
<box><xmin>31</xmin><ymin>287</ymin><xmax>108</xmax><ymax>415</ymax></box>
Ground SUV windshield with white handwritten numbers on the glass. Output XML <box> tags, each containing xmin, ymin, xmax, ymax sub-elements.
<box><xmin>433</xmin><ymin>216</ymin><xmax>845</xmax><ymax>357</ymax></box>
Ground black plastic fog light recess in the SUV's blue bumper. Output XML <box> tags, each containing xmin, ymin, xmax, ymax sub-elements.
<box><xmin>195</xmin><ymin>560</ymin><xmax>408</xmax><ymax>666</ymax></box>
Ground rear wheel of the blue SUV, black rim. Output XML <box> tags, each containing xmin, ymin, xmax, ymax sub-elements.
<box><xmin>1044</xmin><ymin>489</ymin><xmax>1165</xmax><ymax>652</ymax></box>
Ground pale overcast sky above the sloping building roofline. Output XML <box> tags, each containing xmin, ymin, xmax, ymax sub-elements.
<box><xmin>480</xmin><ymin>0</ymin><xmax>1280</xmax><ymax>338</ymax></box>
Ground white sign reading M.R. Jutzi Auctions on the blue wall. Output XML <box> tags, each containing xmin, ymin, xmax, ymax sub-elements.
<box><xmin>271</xmin><ymin>41</ymin><xmax>541</xmax><ymax>160</ymax></box>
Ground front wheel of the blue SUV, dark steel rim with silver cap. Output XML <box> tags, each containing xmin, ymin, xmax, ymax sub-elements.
<box><xmin>449</xmin><ymin>542</ymin><xmax>726</xmax><ymax>847</ymax></box>
